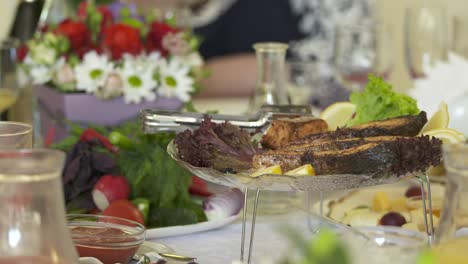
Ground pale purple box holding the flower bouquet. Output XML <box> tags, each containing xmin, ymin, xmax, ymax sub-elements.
<box><xmin>33</xmin><ymin>86</ymin><xmax>183</xmax><ymax>142</ymax></box>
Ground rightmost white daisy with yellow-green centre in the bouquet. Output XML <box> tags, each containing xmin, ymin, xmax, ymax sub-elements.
<box><xmin>158</xmin><ymin>57</ymin><xmax>193</xmax><ymax>102</ymax></box>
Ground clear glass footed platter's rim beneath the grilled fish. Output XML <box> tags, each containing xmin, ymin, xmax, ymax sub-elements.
<box><xmin>167</xmin><ymin>141</ymin><xmax>411</xmax><ymax>191</ymax></box>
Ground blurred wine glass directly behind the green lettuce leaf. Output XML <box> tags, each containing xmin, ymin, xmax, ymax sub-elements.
<box><xmin>334</xmin><ymin>22</ymin><xmax>393</xmax><ymax>91</ymax></box>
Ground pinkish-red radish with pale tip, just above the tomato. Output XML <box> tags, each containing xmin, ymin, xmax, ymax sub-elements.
<box><xmin>93</xmin><ymin>175</ymin><xmax>130</xmax><ymax>211</ymax></box>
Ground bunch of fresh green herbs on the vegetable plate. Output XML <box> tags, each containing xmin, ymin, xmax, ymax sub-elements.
<box><xmin>51</xmin><ymin>121</ymin><xmax>206</xmax><ymax>227</ymax></box>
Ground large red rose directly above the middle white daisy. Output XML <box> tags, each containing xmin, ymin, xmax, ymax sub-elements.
<box><xmin>102</xmin><ymin>24</ymin><xmax>143</xmax><ymax>60</ymax></box>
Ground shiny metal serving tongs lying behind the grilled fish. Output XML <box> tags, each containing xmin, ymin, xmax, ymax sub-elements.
<box><xmin>141</xmin><ymin>105</ymin><xmax>313</xmax><ymax>134</ymax></box>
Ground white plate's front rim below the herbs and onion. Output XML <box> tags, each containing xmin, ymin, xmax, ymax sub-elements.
<box><xmin>146</xmin><ymin>215</ymin><xmax>239</xmax><ymax>239</ymax></box>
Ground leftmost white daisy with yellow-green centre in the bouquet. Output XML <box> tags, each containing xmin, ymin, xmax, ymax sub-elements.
<box><xmin>74</xmin><ymin>51</ymin><xmax>114</xmax><ymax>93</ymax></box>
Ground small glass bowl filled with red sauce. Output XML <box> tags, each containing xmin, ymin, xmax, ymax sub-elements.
<box><xmin>67</xmin><ymin>214</ymin><xmax>145</xmax><ymax>264</ymax></box>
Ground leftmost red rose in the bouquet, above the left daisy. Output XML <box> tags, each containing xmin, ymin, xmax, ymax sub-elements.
<box><xmin>55</xmin><ymin>19</ymin><xmax>91</xmax><ymax>52</ymax></box>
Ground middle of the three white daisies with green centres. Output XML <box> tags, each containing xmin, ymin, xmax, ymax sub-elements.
<box><xmin>120</xmin><ymin>58</ymin><xmax>157</xmax><ymax>103</ymax></box>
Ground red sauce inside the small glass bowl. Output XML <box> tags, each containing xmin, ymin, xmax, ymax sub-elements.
<box><xmin>70</xmin><ymin>227</ymin><xmax>141</xmax><ymax>264</ymax></box>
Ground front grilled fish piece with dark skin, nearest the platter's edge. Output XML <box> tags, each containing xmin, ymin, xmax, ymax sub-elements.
<box><xmin>253</xmin><ymin>136</ymin><xmax>442</xmax><ymax>175</ymax></box>
